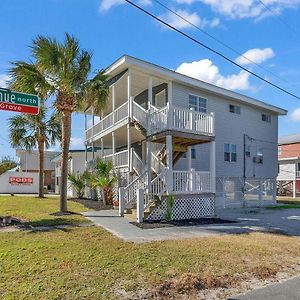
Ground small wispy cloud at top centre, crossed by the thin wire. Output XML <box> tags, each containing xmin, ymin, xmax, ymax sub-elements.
<box><xmin>159</xmin><ymin>9</ymin><xmax>220</xmax><ymax>29</ymax></box>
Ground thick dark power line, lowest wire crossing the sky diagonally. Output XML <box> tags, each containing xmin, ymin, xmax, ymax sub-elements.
<box><xmin>125</xmin><ymin>0</ymin><xmax>300</xmax><ymax>100</ymax></box>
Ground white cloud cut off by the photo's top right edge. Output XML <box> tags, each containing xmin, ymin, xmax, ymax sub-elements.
<box><xmin>195</xmin><ymin>0</ymin><xmax>300</xmax><ymax>19</ymax></box>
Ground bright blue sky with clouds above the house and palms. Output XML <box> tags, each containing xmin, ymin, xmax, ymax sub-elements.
<box><xmin>0</xmin><ymin>0</ymin><xmax>300</xmax><ymax>156</ymax></box>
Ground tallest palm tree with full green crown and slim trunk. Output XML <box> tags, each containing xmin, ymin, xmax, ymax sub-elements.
<box><xmin>9</xmin><ymin>34</ymin><xmax>109</xmax><ymax>213</ymax></box>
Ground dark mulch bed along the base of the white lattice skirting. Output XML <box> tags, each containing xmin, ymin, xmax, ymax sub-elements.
<box><xmin>131</xmin><ymin>218</ymin><xmax>236</xmax><ymax>229</ymax></box>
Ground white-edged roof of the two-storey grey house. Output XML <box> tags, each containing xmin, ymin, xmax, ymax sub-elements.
<box><xmin>106</xmin><ymin>55</ymin><xmax>287</xmax><ymax>115</ymax></box>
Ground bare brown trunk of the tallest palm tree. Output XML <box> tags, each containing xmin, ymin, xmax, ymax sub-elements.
<box><xmin>60</xmin><ymin>111</ymin><xmax>71</xmax><ymax>212</ymax></box>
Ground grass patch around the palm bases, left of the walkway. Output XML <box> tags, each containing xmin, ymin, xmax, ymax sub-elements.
<box><xmin>0</xmin><ymin>196</ymin><xmax>87</xmax><ymax>226</ymax></box>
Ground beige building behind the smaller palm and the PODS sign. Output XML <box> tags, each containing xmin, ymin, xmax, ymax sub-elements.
<box><xmin>16</xmin><ymin>150</ymin><xmax>60</xmax><ymax>191</ymax></box>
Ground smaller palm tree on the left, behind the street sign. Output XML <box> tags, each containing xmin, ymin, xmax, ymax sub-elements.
<box><xmin>9</xmin><ymin>106</ymin><xmax>61</xmax><ymax>198</ymax></box>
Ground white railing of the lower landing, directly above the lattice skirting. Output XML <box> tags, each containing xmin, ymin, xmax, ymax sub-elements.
<box><xmin>173</xmin><ymin>171</ymin><xmax>213</xmax><ymax>194</ymax></box>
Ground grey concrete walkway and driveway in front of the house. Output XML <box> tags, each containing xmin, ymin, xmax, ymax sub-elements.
<box><xmin>83</xmin><ymin>209</ymin><xmax>300</xmax><ymax>242</ymax></box>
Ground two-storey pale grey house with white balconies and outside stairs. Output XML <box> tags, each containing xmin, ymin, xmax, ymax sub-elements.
<box><xmin>86</xmin><ymin>56</ymin><xmax>287</xmax><ymax>221</ymax></box>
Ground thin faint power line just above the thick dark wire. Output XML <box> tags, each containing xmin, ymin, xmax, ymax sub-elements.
<box><xmin>153</xmin><ymin>0</ymin><xmax>290</xmax><ymax>84</ymax></box>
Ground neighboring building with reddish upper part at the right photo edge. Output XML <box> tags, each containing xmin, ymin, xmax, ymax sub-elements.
<box><xmin>277</xmin><ymin>134</ymin><xmax>300</xmax><ymax>198</ymax></box>
